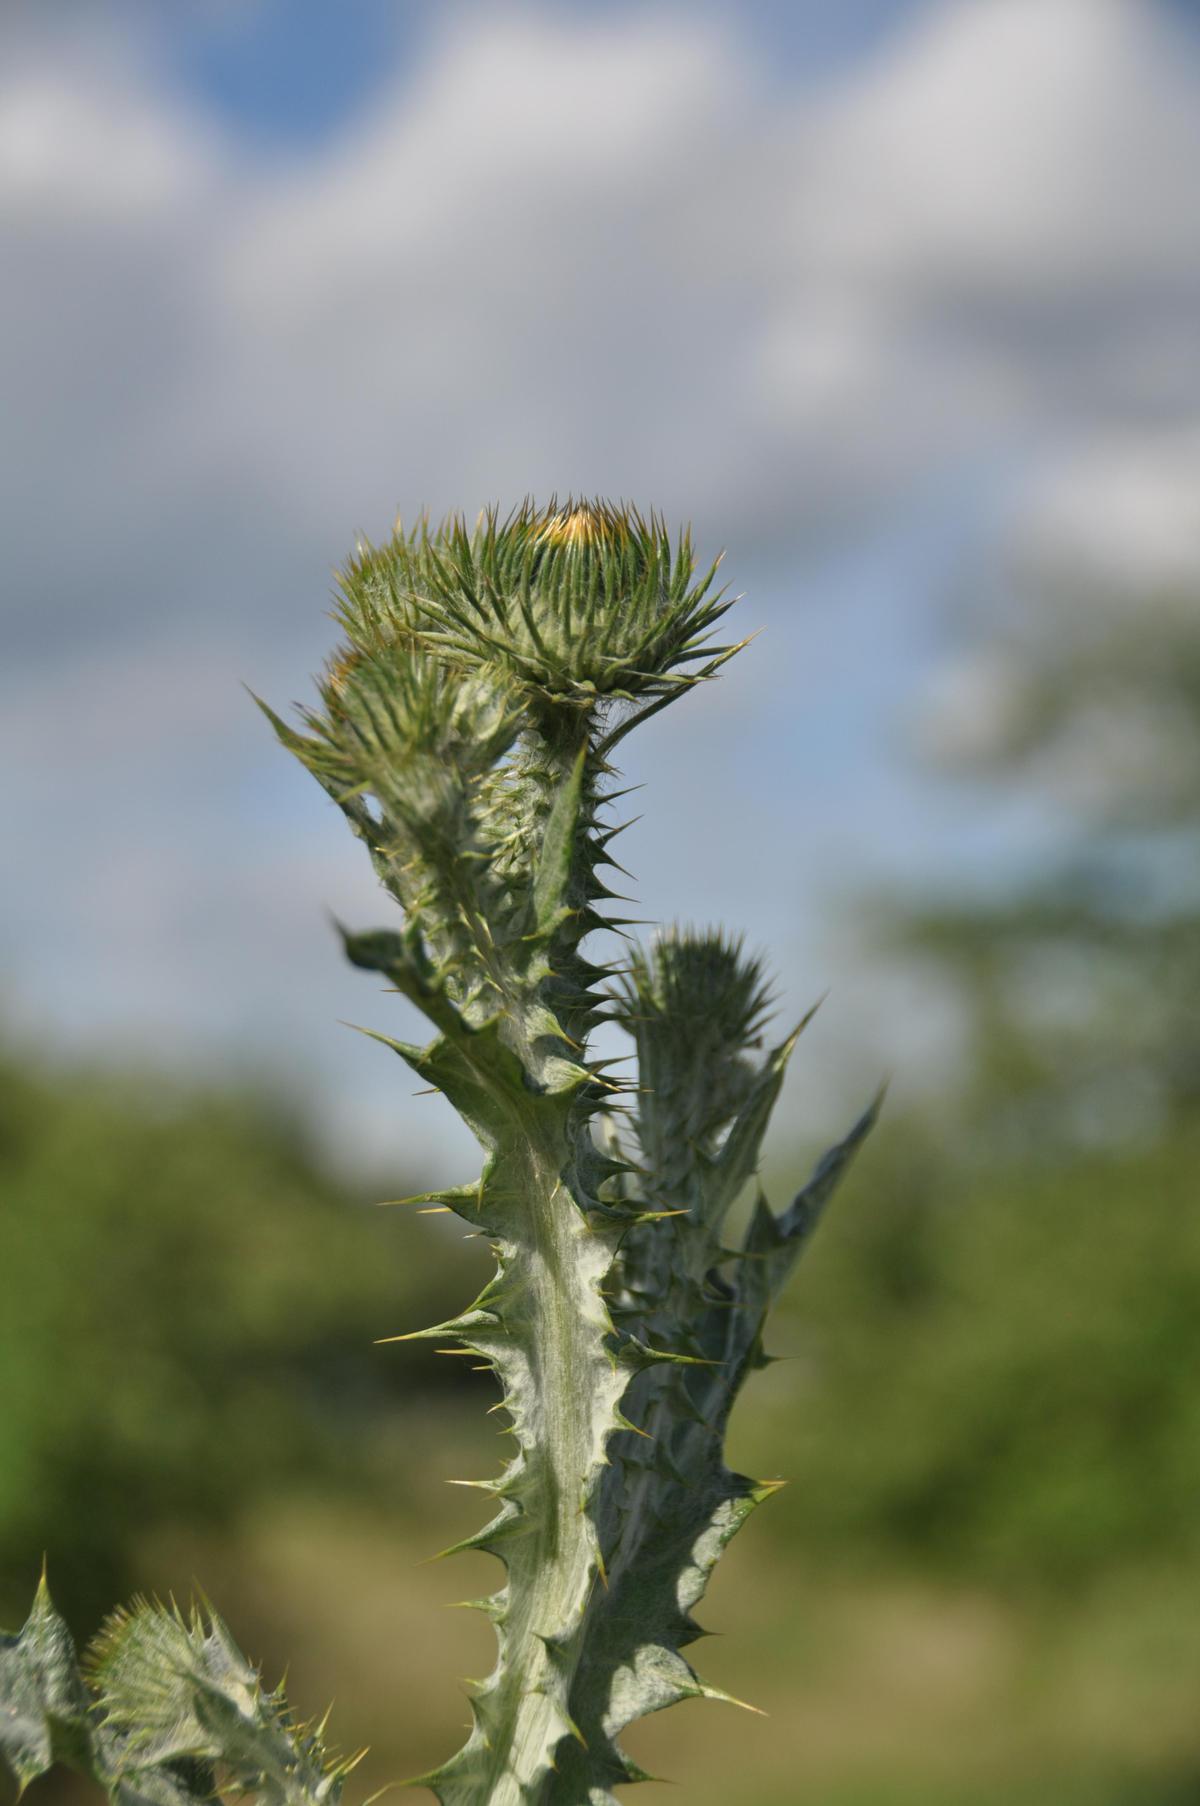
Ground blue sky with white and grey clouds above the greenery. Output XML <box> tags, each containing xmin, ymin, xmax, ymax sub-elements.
<box><xmin>0</xmin><ymin>0</ymin><xmax>1200</xmax><ymax>1165</ymax></box>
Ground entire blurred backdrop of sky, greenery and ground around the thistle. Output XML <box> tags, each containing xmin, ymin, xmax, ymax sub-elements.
<box><xmin>0</xmin><ymin>0</ymin><xmax>1200</xmax><ymax>1806</ymax></box>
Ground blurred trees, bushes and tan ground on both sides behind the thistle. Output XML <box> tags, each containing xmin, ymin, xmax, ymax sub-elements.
<box><xmin>0</xmin><ymin>559</ymin><xmax>1200</xmax><ymax>1806</ymax></box>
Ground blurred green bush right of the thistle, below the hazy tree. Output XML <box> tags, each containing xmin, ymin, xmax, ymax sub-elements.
<box><xmin>764</xmin><ymin>1125</ymin><xmax>1200</xmax><ymax>1589</ymax></box>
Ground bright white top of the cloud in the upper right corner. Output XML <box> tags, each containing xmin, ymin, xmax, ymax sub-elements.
<box><xmin>795</xmin><ymin>0</ymin><xmax>1200</xmax><ymax>297</ymax></box>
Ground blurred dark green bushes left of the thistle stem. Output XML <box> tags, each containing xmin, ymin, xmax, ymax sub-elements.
<box><xmin>0</xmin><ymin>1053</ymin><xmax>477</xmax><ymax>1629</ymax></box>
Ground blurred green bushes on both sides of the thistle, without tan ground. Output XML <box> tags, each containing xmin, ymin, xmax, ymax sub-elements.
<box><xmin>0</xmin><ymin>1033</ymin><xmax>1200</xmax><ymax>1620</ymax></box>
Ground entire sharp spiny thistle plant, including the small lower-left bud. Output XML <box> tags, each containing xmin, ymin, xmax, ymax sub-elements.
<box><xmin>0</xmin><ymin>502</ymin><xmax>873</xmax><ymax>1806</ymax></box>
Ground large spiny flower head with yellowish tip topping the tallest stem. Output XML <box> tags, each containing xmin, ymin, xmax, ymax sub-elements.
<box><xmin>330</xmin><ymin>497</ymin><xmax>736</xmax><ymax>708</ymax></box>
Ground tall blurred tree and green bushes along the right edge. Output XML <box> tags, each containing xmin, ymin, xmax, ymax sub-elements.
<box><xmin>759</xmin><ymin>556</ymin><xmax>1200</xmax><ymax>1586</ymax></box>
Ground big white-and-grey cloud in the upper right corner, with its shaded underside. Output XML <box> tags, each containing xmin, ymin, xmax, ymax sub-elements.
<box><xmin>748</xmin><ymin>0</ymin><xmax>1200</xmax><ymax>498</ymax></box>
